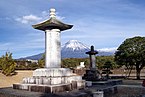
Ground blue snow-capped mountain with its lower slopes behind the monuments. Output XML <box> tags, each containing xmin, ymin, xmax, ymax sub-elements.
<box><xmin>20</xmin><ymin>40</ymin><xmax>115</xmax><ymax>60</ymax></box>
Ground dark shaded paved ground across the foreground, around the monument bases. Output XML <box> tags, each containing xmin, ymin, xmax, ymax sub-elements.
<box><xmin>0</xmin><ymin>80</ymin><xmax>145</xmax><ymax>97</ymax></box>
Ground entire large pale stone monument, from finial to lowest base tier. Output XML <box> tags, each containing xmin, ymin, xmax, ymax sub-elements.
<box><xmin>13</xmin><ymin>8</ymin><xmax>85</xmax><ymax>93</ymax></box>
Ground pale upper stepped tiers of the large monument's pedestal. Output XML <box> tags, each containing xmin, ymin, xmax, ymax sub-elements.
<box><xmin>22</xmin><ymin>68</ymin><xmax>82</xmax><ymax>85</ymax></box>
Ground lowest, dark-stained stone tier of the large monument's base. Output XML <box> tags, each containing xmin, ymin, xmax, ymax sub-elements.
<box><xmin>13</xmin><ymin>81</ymin><xmax>77</xmax><ymax>93</ymax></box>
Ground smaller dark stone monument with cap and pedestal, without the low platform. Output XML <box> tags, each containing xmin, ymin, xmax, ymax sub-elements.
<box><xmin>83</xmin><ymin>46</ymin><xmax>100</xmax><ymax>81</ymax></box>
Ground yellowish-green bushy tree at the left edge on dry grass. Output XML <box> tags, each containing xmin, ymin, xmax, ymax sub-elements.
<box><xmin>0</xmin><ymin>52</ymin><xmax>16</xmax><ymax>76</ymax></box>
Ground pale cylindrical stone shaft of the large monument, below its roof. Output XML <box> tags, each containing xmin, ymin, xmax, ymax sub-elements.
<box><xmin>45</xmin><ymin>29</ymin><xmax>61</xmax><ymax>68</ymax></box>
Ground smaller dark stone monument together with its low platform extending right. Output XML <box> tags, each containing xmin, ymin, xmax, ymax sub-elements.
<box><xmin>82</xmin><ymin>46</ymin><xmax>122</xmax><ymax>87</ymax></box>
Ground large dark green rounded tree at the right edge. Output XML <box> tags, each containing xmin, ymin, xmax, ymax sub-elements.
<box><xmin>115</xmin><ymin>36</ymin><xmax>145</xmax><ymax>79</ymax></box>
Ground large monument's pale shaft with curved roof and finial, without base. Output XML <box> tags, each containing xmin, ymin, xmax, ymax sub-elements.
<box><xmin>32</xmin><ymin>8</ymin><xmax>73</xmax><ymax>68</ymax></box>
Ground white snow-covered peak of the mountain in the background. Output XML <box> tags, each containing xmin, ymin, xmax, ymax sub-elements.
<box><xmin>62</xmin><ymin>40</ymin><xmax>89</xmax><ymax>51</ymax></box>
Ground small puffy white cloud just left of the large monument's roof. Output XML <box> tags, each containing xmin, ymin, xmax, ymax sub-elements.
<box><xmin>15</xmin><ymin>14</ymin><xmax>42</xmax><ymax>24</ymax></box>
